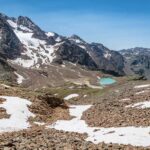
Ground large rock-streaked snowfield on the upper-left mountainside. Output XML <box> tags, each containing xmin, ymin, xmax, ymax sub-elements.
<box><xmin>11</xmin><ymin>29</ymin><xmax>58</xmax><ymax>68</ymax></box>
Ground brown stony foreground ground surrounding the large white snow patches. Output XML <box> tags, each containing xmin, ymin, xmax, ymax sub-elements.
<box><xmin>0</xmin><ymin>81</ymin><xmax>150</xmax><ymax>150</ymax></box>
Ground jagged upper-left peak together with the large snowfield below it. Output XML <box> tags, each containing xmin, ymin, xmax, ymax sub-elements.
<box><xmin>7</xmin><ymin>17</ymin><xmax>57</xmax><ymax>68</ymax></box>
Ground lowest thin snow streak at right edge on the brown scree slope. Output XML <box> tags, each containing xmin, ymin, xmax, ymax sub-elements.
<box><xmin>126</xmin><ymin>101</ymin><xmax>150</xmax><ymax>109</ymax></box>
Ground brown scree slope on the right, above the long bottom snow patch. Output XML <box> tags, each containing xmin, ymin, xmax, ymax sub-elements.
<box><xmin>83</xmin><ymin>82</ymin><xmax>150</xmax><ymax>127</ymax></box>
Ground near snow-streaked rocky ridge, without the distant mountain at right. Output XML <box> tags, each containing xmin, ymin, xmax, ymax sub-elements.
<box><xmin>0</xmin><ymin>14</ymin><xmax>124</xmax><ymax>79</ymax></box>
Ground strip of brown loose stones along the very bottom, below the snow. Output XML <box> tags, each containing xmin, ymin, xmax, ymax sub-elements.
<box><xmin>0</xmin><ymin>127</ymin><xmax>148</xmax><ymax>150</ymax></box>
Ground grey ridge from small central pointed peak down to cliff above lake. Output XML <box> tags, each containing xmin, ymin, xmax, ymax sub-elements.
<box><xmin>69</xmin><ymin>35</ymin><xmax>125</xmax><ymax>75</ymax></box>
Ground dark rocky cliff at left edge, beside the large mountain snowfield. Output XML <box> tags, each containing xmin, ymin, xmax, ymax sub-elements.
<box><xmin>0</xmin><ymin>14</ymin><xmax>22</xmax><ymax>81</ymax></box>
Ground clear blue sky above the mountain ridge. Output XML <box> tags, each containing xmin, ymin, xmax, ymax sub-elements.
<box><xmin>0</xmin><ymin>0</ymin><xmax>150</xmax><ymax>50</ymax></box>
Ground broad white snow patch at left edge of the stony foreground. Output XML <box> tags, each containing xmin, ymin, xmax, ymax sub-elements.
<box><xmin>0</xmin><ymin>96</ymin><xmax>35</xmax><ymax>132</ymax></box>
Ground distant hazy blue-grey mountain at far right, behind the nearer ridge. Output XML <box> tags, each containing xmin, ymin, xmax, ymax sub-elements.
<box><xmin>120</xmin><ymin>47</ymin><xmax>150</xmax><ymax>79</ymax></box>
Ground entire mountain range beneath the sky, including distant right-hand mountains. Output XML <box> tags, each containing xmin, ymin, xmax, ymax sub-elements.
<box><xmin>0</xmin><ymin>13</ymin><xmax>150</xmax><ymax>84</ymax></box>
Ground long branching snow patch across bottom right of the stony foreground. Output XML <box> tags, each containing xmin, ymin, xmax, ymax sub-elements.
<box><xmin>47</xmin><ymin>105</ymin><xmax>150</xmax><ymax>147</ymax></box>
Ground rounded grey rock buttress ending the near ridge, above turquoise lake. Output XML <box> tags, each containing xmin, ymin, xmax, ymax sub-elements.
<box><xmin>89</xmin><ymin>43</ymin><xmax>124</xmax><ymax>75</ymax></box>
